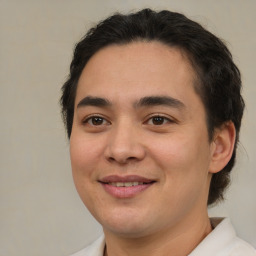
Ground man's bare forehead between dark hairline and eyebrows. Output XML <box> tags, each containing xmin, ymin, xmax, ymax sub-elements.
<box><xmin>76</xmin><ymin>41</ymin><xmax>202</xmax><ymax>108</ymax></box>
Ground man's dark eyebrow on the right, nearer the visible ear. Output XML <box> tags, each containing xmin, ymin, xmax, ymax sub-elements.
<box><xmin>135</xmin><ymin>96</ymin><xmax>185</xmax><ymax>109</ymax></box>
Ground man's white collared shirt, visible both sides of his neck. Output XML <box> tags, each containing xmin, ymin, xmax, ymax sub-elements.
<box><xmin>71</xmin><ymin>218</ymin><xmax>256</xmax><ymax>256</ymax></box>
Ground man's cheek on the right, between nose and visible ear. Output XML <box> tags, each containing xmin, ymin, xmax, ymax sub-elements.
<box><xmin>151</xmin><ymin>132</ymin><xmax>210</xmax><ymax>177</ymax></box>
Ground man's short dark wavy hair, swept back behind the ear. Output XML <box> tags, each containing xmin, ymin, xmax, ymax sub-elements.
<box><xmin>61</xmin><ymin>9</ymin><xmax>244</xmax><ymax>205</ymax></box>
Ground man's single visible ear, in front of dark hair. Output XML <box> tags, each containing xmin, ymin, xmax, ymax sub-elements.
<box><xmin>209</xmin><ymin>122</ymin><xmax>236</xmax><ymax>173</ymax></box>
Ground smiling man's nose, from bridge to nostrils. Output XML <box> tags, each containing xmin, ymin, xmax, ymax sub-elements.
<box><xmin>105</xmin><ymin>122</ymin><xmax>146</xmax><ymax>165</ymax></box>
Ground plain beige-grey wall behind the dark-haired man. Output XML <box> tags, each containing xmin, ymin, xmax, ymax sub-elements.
<box><xmin>0</xmin><ymin>0</ymin><xmax>256</xmax><ymax>256</ymax></box>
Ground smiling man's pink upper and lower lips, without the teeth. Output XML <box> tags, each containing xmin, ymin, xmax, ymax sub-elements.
<box><xmin>99</xmin><ymin>175</ymin><xmax>156</xmax><ymax>199</ymax></box>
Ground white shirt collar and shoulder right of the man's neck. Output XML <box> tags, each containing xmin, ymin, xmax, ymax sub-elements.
<box><xmin>189</xmin><ymin>218</ymin><xmax>256</xmax><ymax>256</ymax></box>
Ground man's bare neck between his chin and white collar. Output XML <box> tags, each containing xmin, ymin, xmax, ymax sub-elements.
<box><xmin>104</xmin><ymin>214</ymin><xmax>212</xmax><ymax>256</ymax></box>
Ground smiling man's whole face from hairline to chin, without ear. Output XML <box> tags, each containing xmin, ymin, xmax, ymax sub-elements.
<box><xmin>70</xmin><ymin>42</ymin><xmax>213</xmax><ymax>237</ymax></box>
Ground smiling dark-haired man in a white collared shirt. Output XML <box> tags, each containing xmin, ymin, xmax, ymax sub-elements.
<box><xmin>61</xmin><ymin>9</ymin><xmax>256</xmax><ymax>256</ymax></box>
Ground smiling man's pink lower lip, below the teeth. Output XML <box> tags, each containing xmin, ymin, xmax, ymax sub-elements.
<box><xmin>101</xmin><ymin>183</ymin><xmax>154</xmax><ymax>198</ymax></box>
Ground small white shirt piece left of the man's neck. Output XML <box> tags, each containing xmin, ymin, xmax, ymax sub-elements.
<box><xmin>70</xmin><ymin>235</ymin><xmax>105</xmax><ymax>256</ymax></box>
